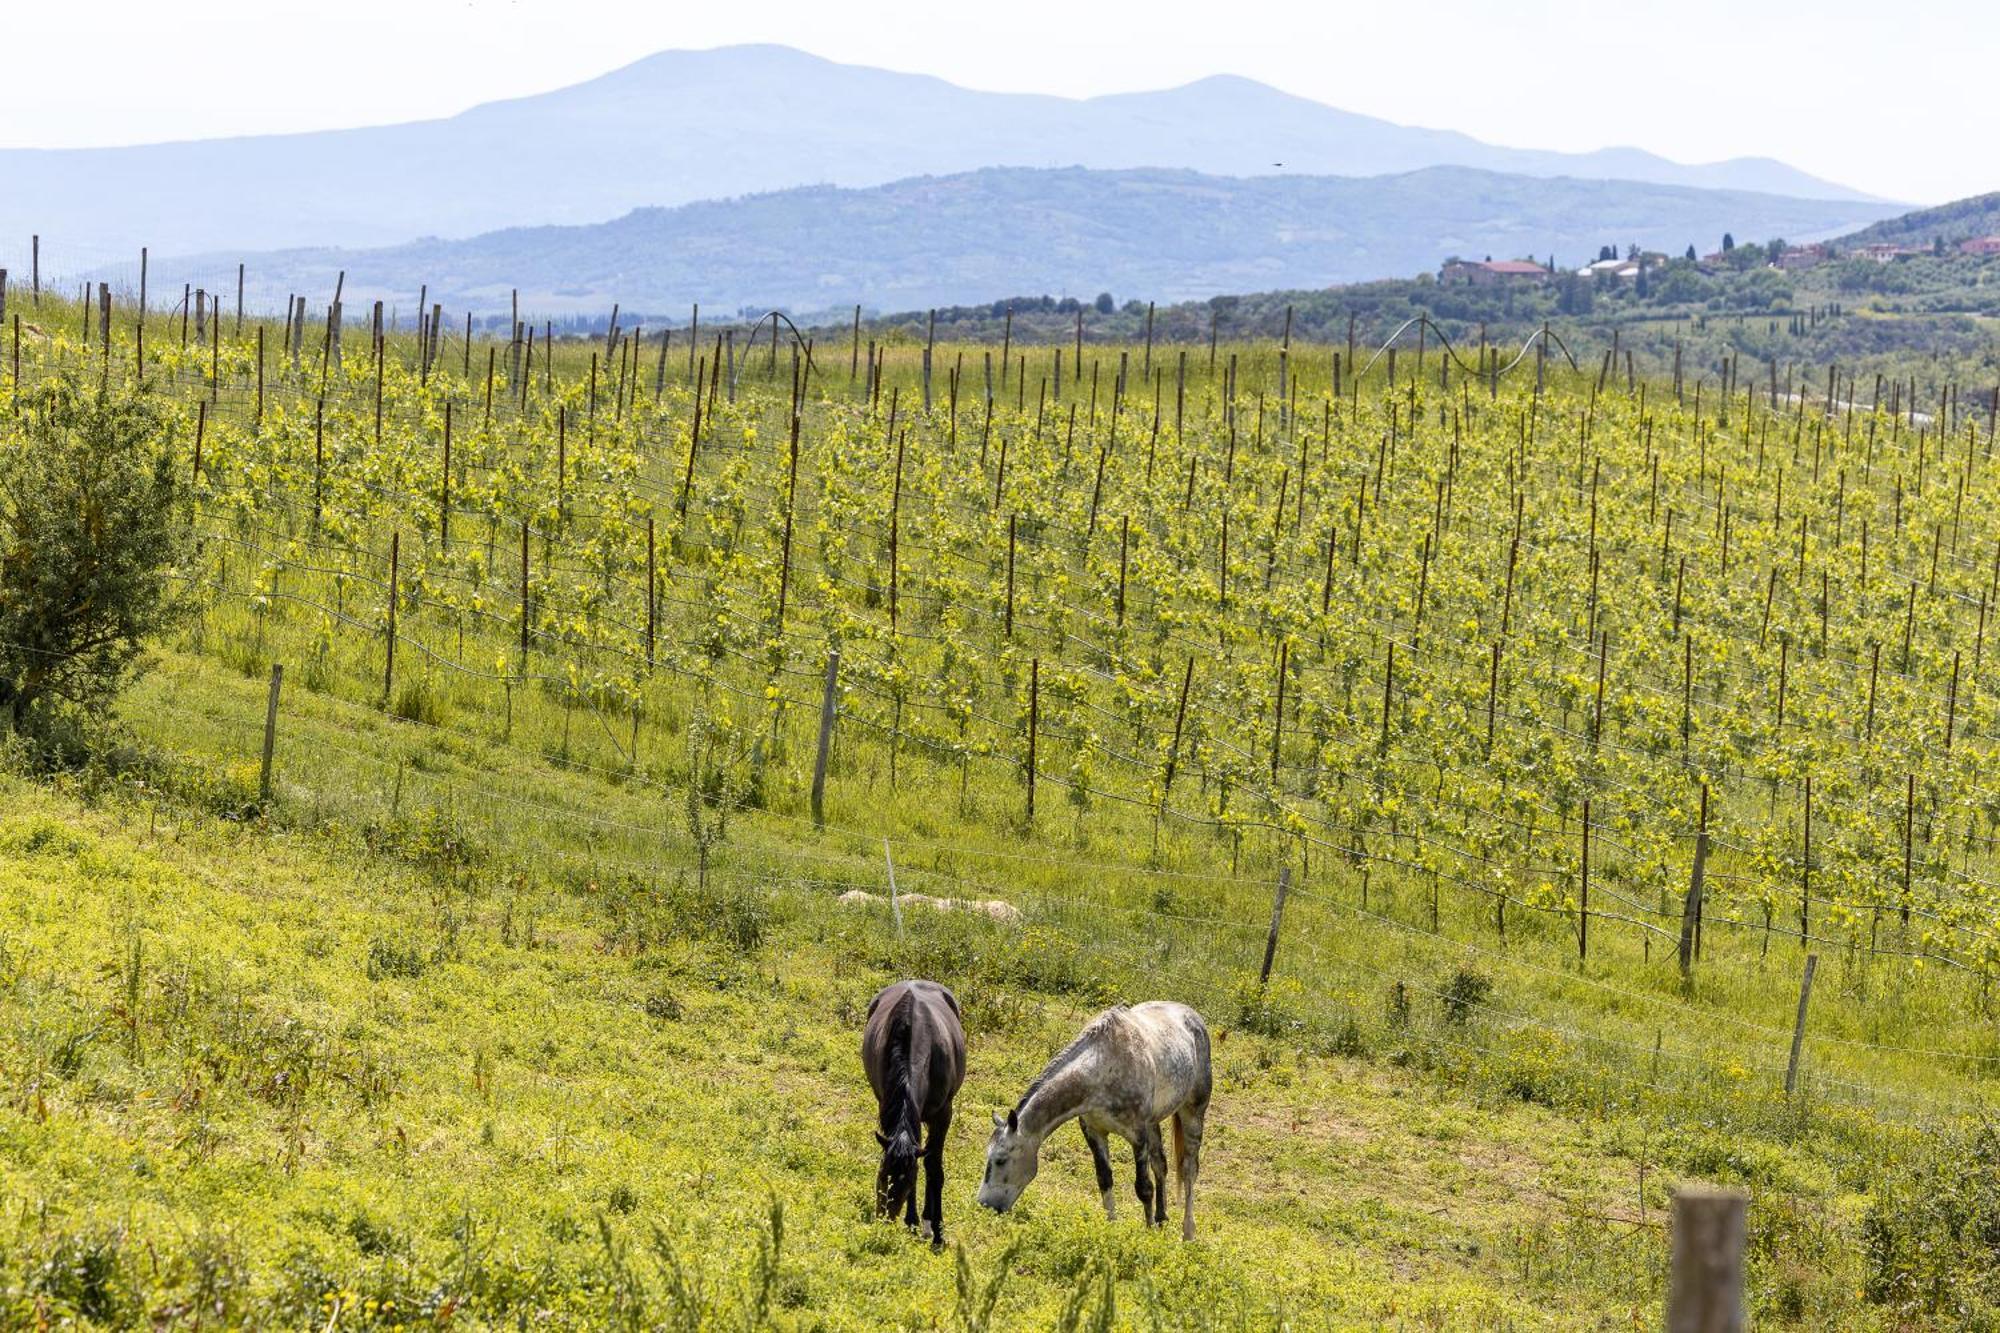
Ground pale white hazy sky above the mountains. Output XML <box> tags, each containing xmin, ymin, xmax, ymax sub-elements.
<box><xmin>0</xmin><ymin>0</ymin><xmax>2000</xmax><ymax>204</ymax></box>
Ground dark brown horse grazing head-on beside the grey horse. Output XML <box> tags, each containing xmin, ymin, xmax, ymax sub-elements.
<box><xmin>862</xmin><ymin>981</ymin><xmax>966</xmax><ymax>1245</ymax></box>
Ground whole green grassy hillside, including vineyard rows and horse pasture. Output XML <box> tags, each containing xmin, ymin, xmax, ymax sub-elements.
<box><xmin>0</xmin><ymin>296</ymin><xmax>2000</xmax><ymax>1329</ymax></box>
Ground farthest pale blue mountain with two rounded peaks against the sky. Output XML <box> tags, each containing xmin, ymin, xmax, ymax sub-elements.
<box><xmin>0</xmin><ymin>46</ymin><xmax>1874</xmax><ymax>268</ymax></box>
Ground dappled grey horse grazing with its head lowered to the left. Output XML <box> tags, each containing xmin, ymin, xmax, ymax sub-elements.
<box><xmin>980</xmin><ymin>1001</ymin><xmax>1214</xmax><ymax>1241</ymax></box>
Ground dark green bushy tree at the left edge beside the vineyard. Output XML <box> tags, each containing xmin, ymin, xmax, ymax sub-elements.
<box><xmin>0</xmin><ymin>380</ymin><xmax>192</xmax><ymax>731</ymax></box>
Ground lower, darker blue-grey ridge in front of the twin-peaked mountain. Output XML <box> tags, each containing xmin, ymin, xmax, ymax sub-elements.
<box><xmin>141</xmin><ymin>166</ymin><xmax>1896</xmax><ymax>316</ymax></box>
